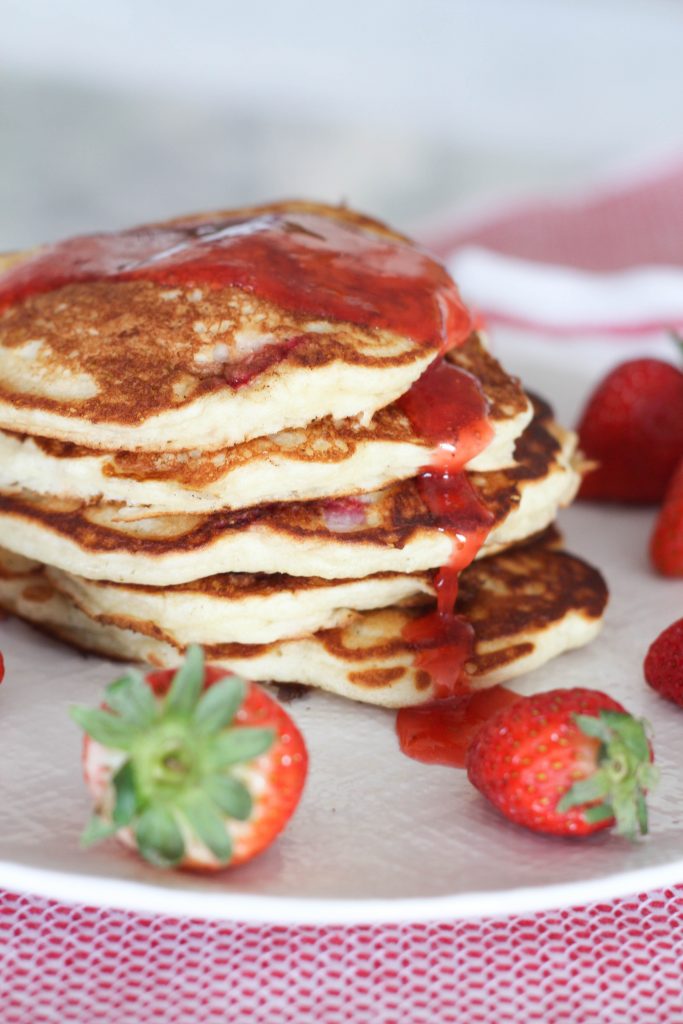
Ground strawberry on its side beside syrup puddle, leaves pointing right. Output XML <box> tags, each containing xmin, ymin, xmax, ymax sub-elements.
<box><xmin>467</xmin><ymin>689</ymin><xmax>656</xmax><ymax>837</ymax></box>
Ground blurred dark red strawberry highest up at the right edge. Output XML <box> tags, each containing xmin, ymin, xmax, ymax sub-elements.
<box><xmin>579</xmin><ymin>359</ymin><xmax>683</xmax><ymax>504</ymax></box>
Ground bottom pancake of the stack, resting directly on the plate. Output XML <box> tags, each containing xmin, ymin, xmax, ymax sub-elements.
<box><xmin>0</xmin><ymin>543</ymin><xmax>607</xmax><ymax>708</ymax></box>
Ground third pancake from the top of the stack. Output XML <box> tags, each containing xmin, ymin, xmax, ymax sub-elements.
<box><xmin>0</xmin><ymin>403</ymin><xmax>580</xmax><ymax>587</ymax></box>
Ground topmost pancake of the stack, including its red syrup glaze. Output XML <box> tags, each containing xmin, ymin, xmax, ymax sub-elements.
<box><xmin>0</xmin><ymin>203</ymin><xmax>470</xmax><ymax>452</ymax></box>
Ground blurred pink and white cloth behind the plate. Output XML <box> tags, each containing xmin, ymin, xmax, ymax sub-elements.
<box><xmin>433</xmin><ymin>159</ymin><xmax>683</xmax><ymax>339</ymax></box>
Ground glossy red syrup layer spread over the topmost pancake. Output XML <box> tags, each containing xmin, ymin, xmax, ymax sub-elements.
<box><xmin>0</xmin><ymin>211</ymin><xmax>471</xmax><ymax>350</ymax></box>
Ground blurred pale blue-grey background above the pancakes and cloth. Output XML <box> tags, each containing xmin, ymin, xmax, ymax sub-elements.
<box><xmin>0</xmin><ymin>0</ymin><xmax>683</xmax><ymax>250</ymax></box>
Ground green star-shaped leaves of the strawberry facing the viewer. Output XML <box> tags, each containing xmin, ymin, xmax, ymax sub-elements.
<box><xmin>71</xmin><ymin>646</ymin><xmax>275</xmax><ymax>867</ymax></box>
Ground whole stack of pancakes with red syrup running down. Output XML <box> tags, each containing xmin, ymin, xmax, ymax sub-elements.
<box><xmin>0</xmin><ymin>203</ymin><xmax>606</xmax><ymax>707</ymax></box>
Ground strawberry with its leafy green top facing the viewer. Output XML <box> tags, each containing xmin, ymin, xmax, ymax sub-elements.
<box><xmin>72</xmin><ymin>646</ymin><xmax>307</xmax><ymax>870</ymax></box>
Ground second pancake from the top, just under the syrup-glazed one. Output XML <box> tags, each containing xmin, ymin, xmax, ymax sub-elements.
<box><xmin>0</xmin><ymin>335</ymin><xmax>531</xmax><ymax>518</ymax></box>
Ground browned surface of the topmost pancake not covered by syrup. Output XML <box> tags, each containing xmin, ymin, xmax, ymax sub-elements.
<box><xmin>0</xmin><ymin>203</ymin><xmax>446</xmax><ymax>426</ymax></box>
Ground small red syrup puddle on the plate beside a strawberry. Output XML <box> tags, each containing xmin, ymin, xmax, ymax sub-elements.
<box><xmin>396</xmin><ymin>686</ymin><xmax>525</xmax><ymax>768</ymax></box>
